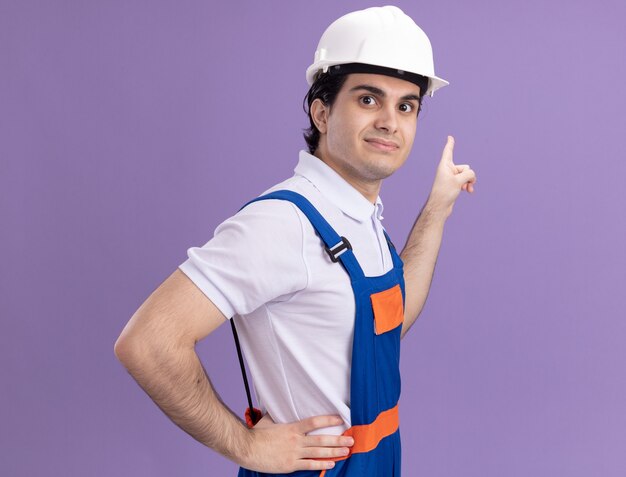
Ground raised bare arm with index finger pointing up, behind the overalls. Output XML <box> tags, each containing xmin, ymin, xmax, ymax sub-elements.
<box><xmin>400</xmin><ymin>136</ymin><xmax>476</xmax><ymax>337</ymax></box>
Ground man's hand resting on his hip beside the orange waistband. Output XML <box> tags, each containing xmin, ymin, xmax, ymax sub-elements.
<box><xmin>240</xmin><ymin>414</ymin><xmax>354</xmax><ymax>473</ymax></box>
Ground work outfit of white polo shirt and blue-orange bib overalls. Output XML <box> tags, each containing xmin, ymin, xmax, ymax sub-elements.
<box><xmin>180</xmin><ymin>151</ymin><xmax>403</xmax><ymax>476</ymax></box>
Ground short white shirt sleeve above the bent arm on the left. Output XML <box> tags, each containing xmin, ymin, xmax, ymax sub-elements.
<box><xmin>179</xmin><ymin>199</ymin><xmax>308</xmax><ymax>318</ymax></box>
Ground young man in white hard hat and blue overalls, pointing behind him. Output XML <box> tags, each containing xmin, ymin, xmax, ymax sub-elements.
<box><xmin>115</xmin><ymin>7</ymin><xmax>476</xmax><ymax>477</ymax></box>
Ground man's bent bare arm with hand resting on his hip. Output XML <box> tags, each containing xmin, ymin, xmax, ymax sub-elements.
<box><xmin>115</xmin><ymin>270</ymin><xmax>352</xmax><ymax>472</ymax></box>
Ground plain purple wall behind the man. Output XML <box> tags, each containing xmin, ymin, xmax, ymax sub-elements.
<box><xmin>0</xmin><ymin>0</ymin><xmax>626</xmax><ymax>477</ymax></box>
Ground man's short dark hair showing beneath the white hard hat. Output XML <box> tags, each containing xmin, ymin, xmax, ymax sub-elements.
<box><xmin>302</xmin><ymin>68</ymin><xmax>428</xmax><ymax>154</ymax></box>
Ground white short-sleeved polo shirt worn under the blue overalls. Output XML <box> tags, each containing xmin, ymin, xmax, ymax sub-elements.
<box><xmin>180</xmin><ymin>151</ymin><xmax>393</xmax><ymax>434</ymax></box>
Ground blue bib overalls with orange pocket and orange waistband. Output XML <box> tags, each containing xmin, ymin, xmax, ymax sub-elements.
<box><xmin>238</xmin><ymin>190</ymin><xmax>404</xmax><ymax>477</ymax></box>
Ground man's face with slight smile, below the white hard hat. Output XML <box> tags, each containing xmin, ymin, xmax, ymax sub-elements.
<box><xmin>316</xmin><ymin>73</ymin><xmax>420</xmax><ymax>190</ymax></box>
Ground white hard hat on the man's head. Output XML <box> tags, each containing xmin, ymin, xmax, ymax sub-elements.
<box><xmin>306</xmin><ymin>6</ymin><xmax>449</xmax><ymax>96</ymax></box>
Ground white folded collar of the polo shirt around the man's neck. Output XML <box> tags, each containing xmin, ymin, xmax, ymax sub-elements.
<box><xmin>294</xmin><ymin>151</ymin><xmax>383</xmax><ymax>222</ymax></box>
